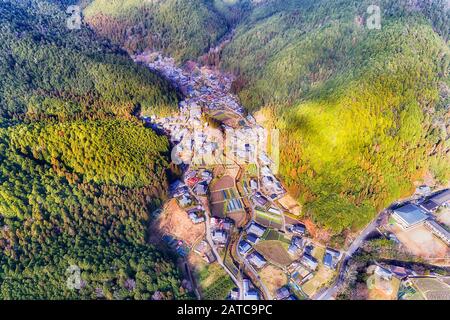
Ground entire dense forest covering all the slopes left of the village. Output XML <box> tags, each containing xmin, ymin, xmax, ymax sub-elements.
<box><xmin>0</xmin><ymin>0</ymin><xmax>189</xmax><ymax>299</ymax></box>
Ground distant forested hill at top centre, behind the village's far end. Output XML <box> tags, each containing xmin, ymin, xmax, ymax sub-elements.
<box><xmin>84</xmin><ymin>0</ymin><xmax>249</xmax><ymax>61</ymax></box>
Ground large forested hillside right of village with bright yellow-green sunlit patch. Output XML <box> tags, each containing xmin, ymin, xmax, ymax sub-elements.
<box><xmin>222</xmin><ymin>0</ymin><xmax>450</xmax><ymax>233</ymax></box>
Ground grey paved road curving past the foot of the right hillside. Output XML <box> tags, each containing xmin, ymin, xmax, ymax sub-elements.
<box><xmin>312</xmin><ymin>210</ymin><xmax>386</xmax><ymax>300</ymax></box>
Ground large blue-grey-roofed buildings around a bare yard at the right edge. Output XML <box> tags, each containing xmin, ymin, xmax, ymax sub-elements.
<box><xmin>392</xmin><ymin>189</ymin><xmax>450</xmax><ymax>245</ymax></box>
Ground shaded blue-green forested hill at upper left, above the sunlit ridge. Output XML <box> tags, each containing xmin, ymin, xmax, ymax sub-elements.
<box><xmin>0</xmin><ymin>0</ymin><xmax>177</xmax><ymax>120</ymax></box>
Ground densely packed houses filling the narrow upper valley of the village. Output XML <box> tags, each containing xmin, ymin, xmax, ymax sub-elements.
<box><xmin>143</xmin><ymin>53</ymin><xmax>286</xmax><ymax>200</ymax></box>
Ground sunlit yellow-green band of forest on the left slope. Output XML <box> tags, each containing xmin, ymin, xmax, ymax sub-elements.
<box><xmin>9</xmin><ymin>120</ymin><xmax>169</xmax><ymax>187</ymax></box>
